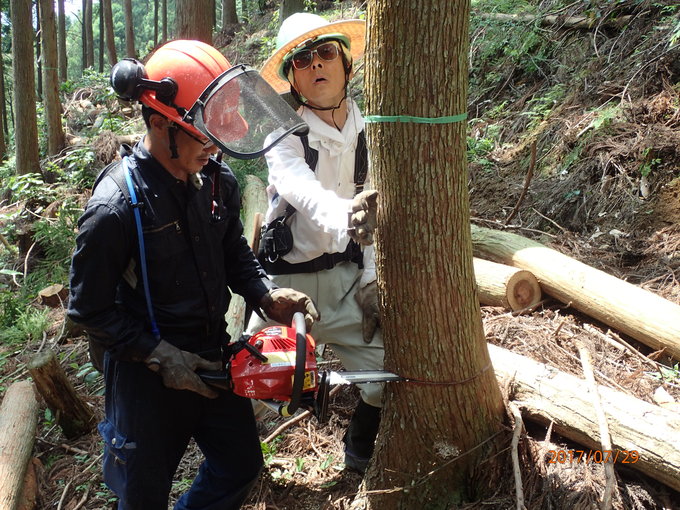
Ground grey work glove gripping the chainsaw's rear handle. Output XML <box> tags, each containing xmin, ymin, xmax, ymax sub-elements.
<box><xmin>144</xmin><ymin>340</ymin><xmax>222</xmax><ymax>398</ymax></box>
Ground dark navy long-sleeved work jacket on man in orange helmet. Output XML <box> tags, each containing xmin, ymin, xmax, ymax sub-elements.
<box><xmin>68</xmin><ymin>142</ymin><xmax>276</xmax><ymax>361</ymax></box>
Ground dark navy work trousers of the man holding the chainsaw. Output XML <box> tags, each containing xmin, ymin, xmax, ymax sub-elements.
<box><xmin>99</xmin><ymin>354</ymin><xmax>262</xmax><ymax>510</ymax></box>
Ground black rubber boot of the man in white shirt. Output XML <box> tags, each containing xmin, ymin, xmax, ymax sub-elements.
<box><xmin>343</xmin><ymin>400</ymin><xmax>380</xmax><ymax>475</ymax></box>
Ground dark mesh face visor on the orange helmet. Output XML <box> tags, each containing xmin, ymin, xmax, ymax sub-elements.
<box><xmin>189</xmin><ymin>66</ymin><xmax>309</xmax><ymax>159</ymax></box>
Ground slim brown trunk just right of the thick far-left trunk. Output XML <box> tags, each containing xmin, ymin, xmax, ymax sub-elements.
<box><xmin>39</xmin><ymin>0</ymin><xmax>65</xmax><ymax>156</ymax></box>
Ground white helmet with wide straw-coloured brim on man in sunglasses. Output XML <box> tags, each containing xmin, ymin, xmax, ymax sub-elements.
<box><xmin>260</xmin><ymin>12</ymin><xmax>366</xmax><ymax>94</ymax></box>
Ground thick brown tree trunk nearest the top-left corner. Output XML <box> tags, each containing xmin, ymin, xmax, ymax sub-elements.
<box><xmin>10</xmin><ymin>0</ymin><xmax>40</xmax><ymax>174</ymax></box>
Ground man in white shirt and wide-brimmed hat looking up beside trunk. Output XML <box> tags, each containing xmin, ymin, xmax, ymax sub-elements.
<box><xmin>248</xmin><ymin>13</ymin><xmax>384</xmax><ymax>473</ymax></box>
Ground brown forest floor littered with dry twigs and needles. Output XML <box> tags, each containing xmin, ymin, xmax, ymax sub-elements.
<box><xmin>0</xmin><ymin>2</ymin><xmax>680</xmax><ymax>510</ymax></box>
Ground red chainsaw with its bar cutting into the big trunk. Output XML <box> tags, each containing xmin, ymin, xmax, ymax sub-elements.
<box><xmin>198</xmin><ymin>313</ymin><xmax>403</xmax><ymax>423</ymax></box>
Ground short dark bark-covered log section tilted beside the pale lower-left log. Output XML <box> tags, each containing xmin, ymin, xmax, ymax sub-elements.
<box><xmin>28</xmin><ymin>349</ymin><xmax>95</xmax><ymax>439</ymax></box>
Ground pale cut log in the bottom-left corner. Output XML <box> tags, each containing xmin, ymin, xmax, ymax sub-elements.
<box><xmin>0</xmin><ymin>381</ymin><xmax>39</xmax><ymax>510</ymax></box>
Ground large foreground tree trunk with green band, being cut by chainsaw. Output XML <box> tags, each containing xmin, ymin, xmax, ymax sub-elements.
<box><xmin>364</xmin><ymin>0</ymin><xmax>504</xmax><ymax>510</ymax></box>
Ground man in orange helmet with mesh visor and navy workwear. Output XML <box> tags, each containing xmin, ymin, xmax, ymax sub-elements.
<box><xmin>68</xmin><ymin>41</ymin><xmax>318</xmax><ymax>510</ymax></box>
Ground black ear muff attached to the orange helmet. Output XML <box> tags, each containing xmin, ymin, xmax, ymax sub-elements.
<box><xmin>111</xmin><ymin>58</ymin><xmax>177</xmax><ymax>106</ymax></box>
